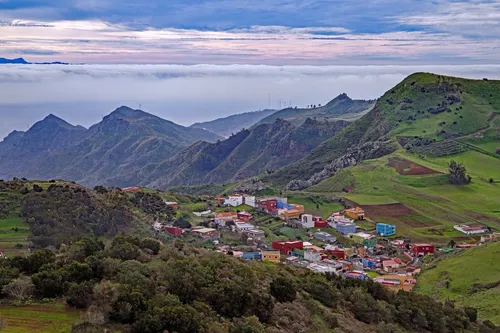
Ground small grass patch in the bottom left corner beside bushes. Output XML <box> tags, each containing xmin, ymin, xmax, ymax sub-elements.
<box><xmin>0</xmin><ymin>304</ymin><xmax>78</xmax><ymax>333</ymax></box>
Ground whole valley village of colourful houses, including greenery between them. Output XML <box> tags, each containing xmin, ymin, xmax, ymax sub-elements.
<box><xmin>153</xmin><ymin>194</ymin><xmax>500</xmax><ymax>291</ymax></box>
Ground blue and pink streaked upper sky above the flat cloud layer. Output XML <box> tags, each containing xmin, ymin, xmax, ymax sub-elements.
<box><xmin>0</xmin><ymin>0</ymin><xmax>500</xmax><ymax>65</ymax></box>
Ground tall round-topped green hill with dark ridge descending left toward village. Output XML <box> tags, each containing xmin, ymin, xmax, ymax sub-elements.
<box><xmin>264</xmin><ymin>73</ymin><xmax>500</xmax><ymax>186</ymax></box>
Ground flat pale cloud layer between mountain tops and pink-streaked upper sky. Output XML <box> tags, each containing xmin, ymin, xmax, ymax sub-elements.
<box><xmin>0</xmin><ymin>65</ymin><xmax>500</xmax><ymax>138</ymax></box>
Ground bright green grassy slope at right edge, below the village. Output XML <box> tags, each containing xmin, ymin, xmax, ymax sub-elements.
<box><xmin>418</xmin><ymin>242</ymin><xmax>500</xmax><ymax>325</ymax></box>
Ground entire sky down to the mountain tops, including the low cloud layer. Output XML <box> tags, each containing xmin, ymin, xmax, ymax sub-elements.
<box><xmin>0</xmin><ymin>0</ymin><xmax>500</xmax><ymax>139</ymax></box>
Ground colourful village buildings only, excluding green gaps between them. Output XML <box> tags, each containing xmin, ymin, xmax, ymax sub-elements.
<box><xmin>150</xmin><ymin>195</ymin><xmax>498</xmax><ymax>290</ymax></box>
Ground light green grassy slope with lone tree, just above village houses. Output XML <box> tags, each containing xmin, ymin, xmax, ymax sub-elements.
<box><xmin>309</xmin><ymin>151</ymin><xmax>500</xmax><ymax>243</ymax></box>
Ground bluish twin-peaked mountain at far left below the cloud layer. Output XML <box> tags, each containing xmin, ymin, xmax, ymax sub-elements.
<box><xmin>0</xmin><ymin>107</ymin><xmax>222</xmax><ymax>184</ymax></box>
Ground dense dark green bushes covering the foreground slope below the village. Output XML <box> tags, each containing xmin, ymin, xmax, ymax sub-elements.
<box><xmin>0</xmin><ymin>236</ymin><xmax>500</xmax><ymax>333</ymax></box>
